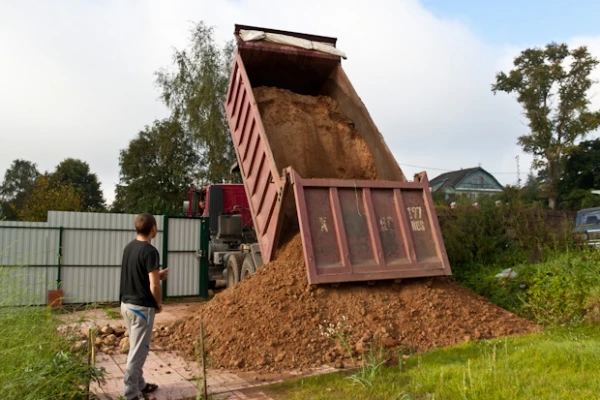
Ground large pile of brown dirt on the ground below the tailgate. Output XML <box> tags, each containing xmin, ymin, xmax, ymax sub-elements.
<box><xmin>156</xmin><ymin>236</ymin><xmax>536</xmax><ymax>370</ymax></box>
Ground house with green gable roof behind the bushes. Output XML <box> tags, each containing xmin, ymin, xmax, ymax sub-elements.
<box><xmin>429</xmin><ymin>167</ymin><xmax>502</xmax><ymax>199</ymax></box>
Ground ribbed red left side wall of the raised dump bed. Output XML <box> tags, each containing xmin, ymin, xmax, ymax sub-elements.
<box><xmin>225</xmin><ymin>54</ymin><xmax>284</xmax><ymax>262</ymax></box>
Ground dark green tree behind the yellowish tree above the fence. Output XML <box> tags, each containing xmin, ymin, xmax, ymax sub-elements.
<box><xmin>52</xmin><ymin>158</ymin><xmax>105</xmax><ymax>211</ymax></box>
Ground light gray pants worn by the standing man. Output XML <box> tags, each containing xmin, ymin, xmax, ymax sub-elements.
<box><xmin>121</xmin><ymin>303</ymin><xmax>156</xmax><ymax>399</ymax></box>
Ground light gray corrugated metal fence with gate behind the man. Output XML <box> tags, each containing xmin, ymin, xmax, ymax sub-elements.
<box><xmin>0</xmin><ymin>211</ymin><xmax>203</xmax><ymax>305</ymax></box>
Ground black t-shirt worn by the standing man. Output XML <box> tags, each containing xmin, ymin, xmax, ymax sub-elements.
<box><xmin>120</xmin><ymin>240</ymin><xmax>159</xmax><ymax>308</ymax></box>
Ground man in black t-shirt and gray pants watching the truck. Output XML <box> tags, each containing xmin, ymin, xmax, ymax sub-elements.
<box><xmin>120</xmin><ymin>214</ymin><xmax>168</xmax><ymax>400</ymax></box>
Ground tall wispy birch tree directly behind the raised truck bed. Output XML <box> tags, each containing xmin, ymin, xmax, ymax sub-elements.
<box><xmin>156</xmin><ymin>22</ymin><xmax>240</xmax><ymax>183</ymax></box>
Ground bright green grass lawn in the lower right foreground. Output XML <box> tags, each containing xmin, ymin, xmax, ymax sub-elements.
<box><xmin>266</xmin><ymin>325</ymin><xmax>600</xmax><ymax>400</ymax></box>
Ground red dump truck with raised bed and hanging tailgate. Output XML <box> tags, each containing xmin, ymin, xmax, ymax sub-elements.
<box><xmin>197</xmin><ymin>25</ymin><xmax>451</xmax><ymax>284</ymax></box>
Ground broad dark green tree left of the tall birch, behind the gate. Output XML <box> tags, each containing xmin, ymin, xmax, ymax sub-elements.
<box><xmin>113</xmin><ymin>119</ymin><xmax>199</xmax><ymax>215</ymax></box>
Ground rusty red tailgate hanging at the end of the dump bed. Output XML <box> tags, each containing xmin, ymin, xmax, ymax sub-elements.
<box><xmin>287</xmin><ymin>168</ymin><xmax>452</xmax><ymax>284</ymax></box>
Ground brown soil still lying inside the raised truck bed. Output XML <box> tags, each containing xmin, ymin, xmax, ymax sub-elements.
<box><xmin>254</xmin><ymin>87</ymin><xmax>377</xmax><ymax>180</ymax></box>
